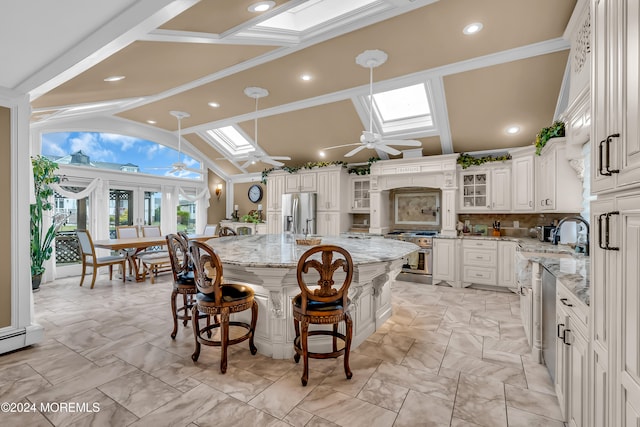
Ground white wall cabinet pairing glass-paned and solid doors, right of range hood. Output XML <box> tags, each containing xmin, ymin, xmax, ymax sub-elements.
<box><xmin>459</xmin><ymin>167</ymin><xmax>511</xmax><ymax>212</ymax></box>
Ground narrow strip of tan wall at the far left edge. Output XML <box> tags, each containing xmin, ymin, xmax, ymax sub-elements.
<box><xmin>0</xmin><ymin>107</ymin><xmax>11</xmax><ymax>328</ymax></box>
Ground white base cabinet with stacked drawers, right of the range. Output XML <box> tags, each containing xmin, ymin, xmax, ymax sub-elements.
<box><xmin>462</xmin><ymin>239</ymin><xmax>498</xmax><ymax>286</ymax></box>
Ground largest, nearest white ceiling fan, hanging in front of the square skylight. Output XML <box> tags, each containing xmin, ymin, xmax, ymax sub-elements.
<box><xmin>325</xmin><ymin>49</ymin><xmax>422</xmax><ymax>157</ymax></box>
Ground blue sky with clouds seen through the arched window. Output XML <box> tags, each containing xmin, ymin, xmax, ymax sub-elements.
<box><xmin>42</xmin><ymin>132</ymin><xmax>200</xmax><ymax>175</ymax></box>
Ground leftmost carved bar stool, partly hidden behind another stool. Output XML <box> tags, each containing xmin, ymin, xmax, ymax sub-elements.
<box><xmin>166</xmin><ymin>234</ymin><xmax>208</xmax><ymax>339</ymax></box>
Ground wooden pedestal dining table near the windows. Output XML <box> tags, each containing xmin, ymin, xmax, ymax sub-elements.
<box><xmin>93</xmin><ymin>234</ymin><xmax>216</xmax><ymax>282</ymax></box>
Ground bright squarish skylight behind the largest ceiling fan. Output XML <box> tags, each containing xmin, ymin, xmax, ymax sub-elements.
<box><xmin>365</xmin><ymin>83</ymin><xmax>434</xmax><ymax>133</ymax></box>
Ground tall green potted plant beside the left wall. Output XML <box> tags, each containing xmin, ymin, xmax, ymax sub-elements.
<box><xmin>30</xmin><ymin>156</ymin><xmax>60</xmax><ymax>290</ymax></box>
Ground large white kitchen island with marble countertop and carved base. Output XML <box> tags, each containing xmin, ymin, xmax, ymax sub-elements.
<box><xmin>202</xmin><ymin>234</ymin><xmax>418</xmax><ymax>359</ymax></box>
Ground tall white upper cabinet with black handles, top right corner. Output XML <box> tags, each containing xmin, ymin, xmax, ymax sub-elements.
<box><xmin>591</xmin><ymin>0</ymin><xmax>640</xmax><ymax>193</ymax></box>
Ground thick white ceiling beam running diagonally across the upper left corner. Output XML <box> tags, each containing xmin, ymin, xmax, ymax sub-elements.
<box><xmin>21</xmin><ymin>0</ymin><xmax>200</xmax><ymax>101</ymax></box>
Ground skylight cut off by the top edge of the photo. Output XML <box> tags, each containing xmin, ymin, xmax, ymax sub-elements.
<box><xmin>257</xmin><ymin>0</ymin><xmax>380</xmax><ymax>32</ymax></box>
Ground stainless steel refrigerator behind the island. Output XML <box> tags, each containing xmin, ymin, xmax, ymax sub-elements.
<box><xmin>282</xmin><ymin>193</ymin><xmax>317</xmax><ymax>234</ymax></box>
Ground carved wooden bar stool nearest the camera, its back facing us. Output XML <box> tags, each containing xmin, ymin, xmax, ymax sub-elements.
<box><xmin>291</xmin><ymin>245</ymin><xmax>353</xmax><ymax>386</ymax></box>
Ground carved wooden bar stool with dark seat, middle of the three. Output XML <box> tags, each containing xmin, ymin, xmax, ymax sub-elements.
<box><xmin>189</xmin><ymin>240</ymin><xmax>258</xmax><ymax>374</ymax></box>
